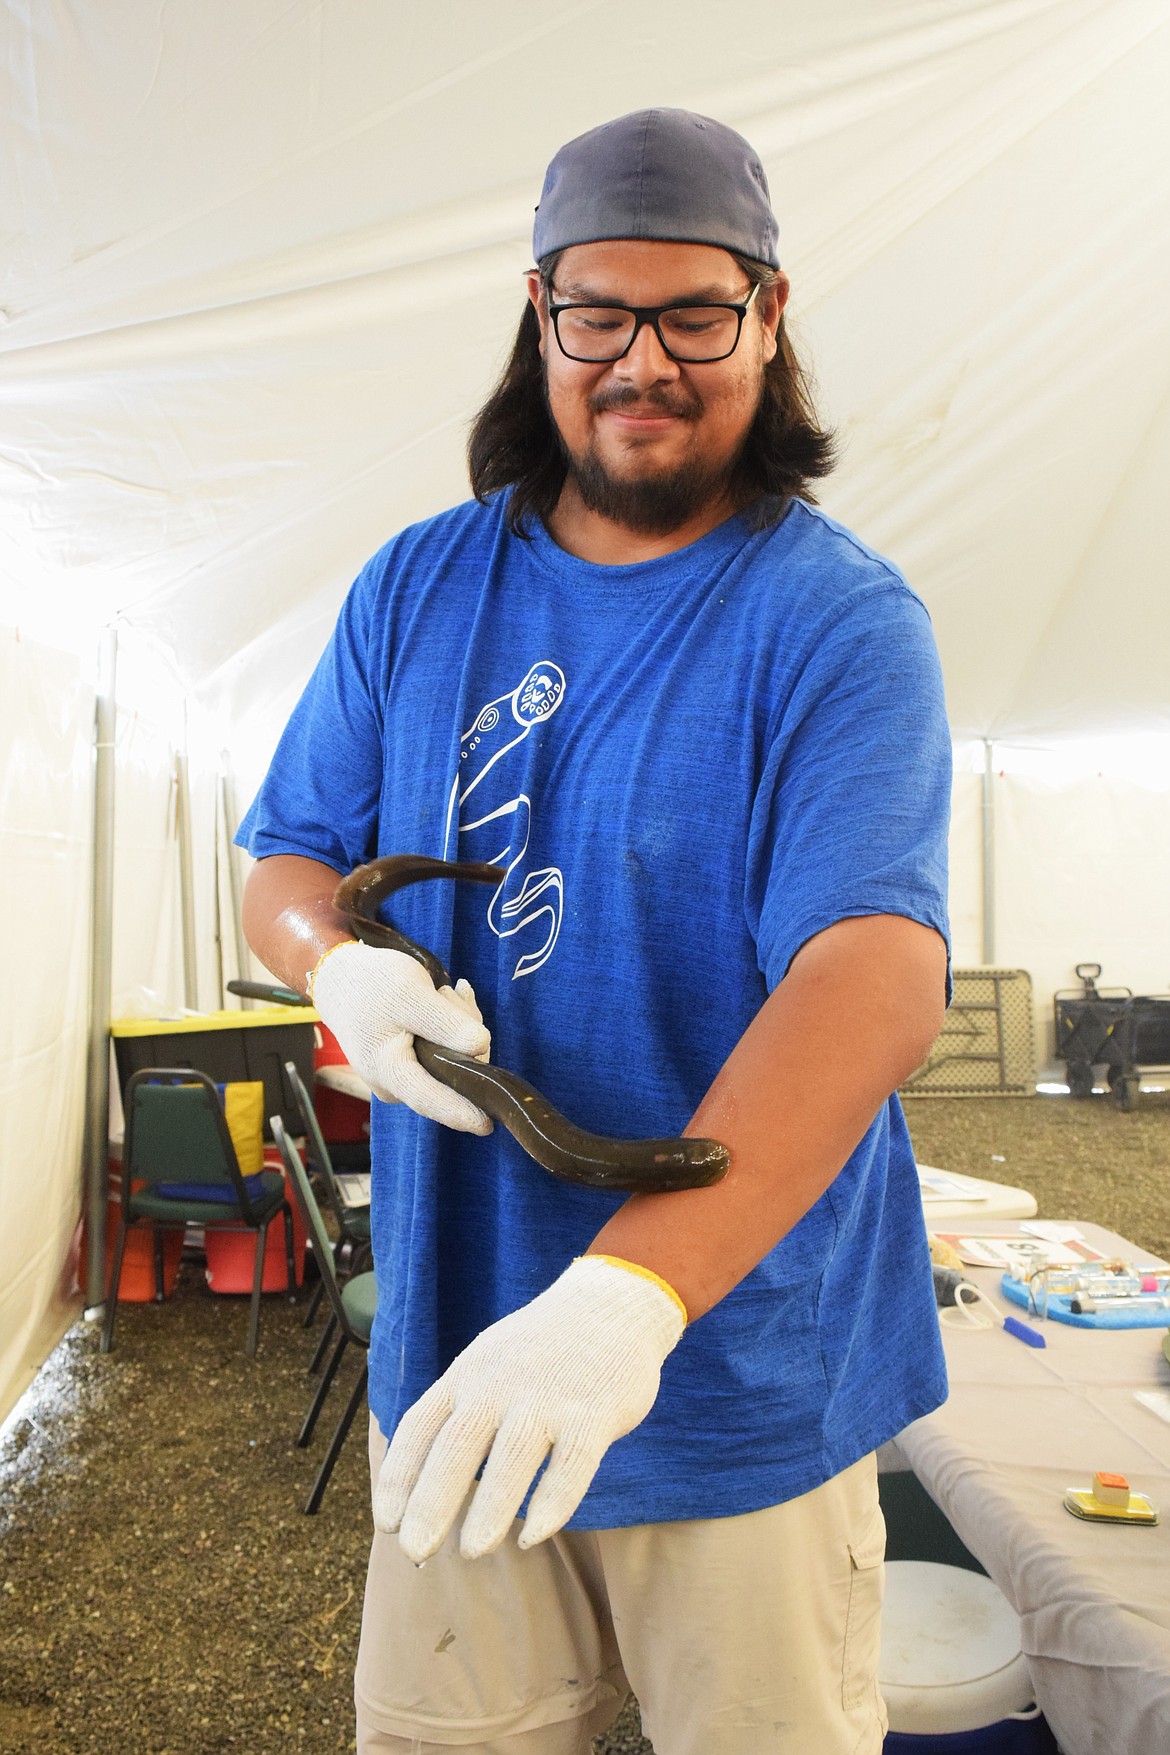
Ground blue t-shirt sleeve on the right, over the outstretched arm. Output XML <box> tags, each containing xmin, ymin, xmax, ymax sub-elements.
<box><xmin>744</xmin><ymin>579</ymin><xmax>951</xmax><ymax>999</ymax></box>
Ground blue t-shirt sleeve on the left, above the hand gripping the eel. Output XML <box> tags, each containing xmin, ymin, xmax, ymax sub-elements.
<box><xmin>235</xmin><ymin>563</ymin><xmax>382</xmax><ymax>872</ymax></box>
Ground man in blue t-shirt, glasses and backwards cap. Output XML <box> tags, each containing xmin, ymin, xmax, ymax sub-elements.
<box><xmin>240</xmin><ymin>111</ymin><xmax>949</xmax><ymax>1755</ymax></box>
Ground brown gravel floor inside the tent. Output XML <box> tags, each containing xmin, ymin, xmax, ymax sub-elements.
<box><xmin>0</xmin><ymin>1093</ymin><xmax>1170</xmax><ymax>1755</ymax></box>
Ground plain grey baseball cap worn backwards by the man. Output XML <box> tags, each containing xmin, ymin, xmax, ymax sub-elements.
<box><xmin>531</xmin><ymin>109</ymin><xmax>781</xmax><ymax>269</ymax></box>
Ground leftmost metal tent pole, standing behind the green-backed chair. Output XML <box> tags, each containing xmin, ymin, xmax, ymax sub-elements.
<box><xmin>82</xmin><ymin>628</ymin><xmax>118</xmax><ymax>1311</ymax></box>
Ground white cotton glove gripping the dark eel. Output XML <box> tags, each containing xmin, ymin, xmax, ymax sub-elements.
<box><xmin>309</xmin><ymin>939</ymin><xmax>491</xmax><ymax>1134</ymax></box>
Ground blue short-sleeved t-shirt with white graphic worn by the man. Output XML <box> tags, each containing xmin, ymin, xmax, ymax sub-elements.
<box><xmin>239</xmin><ymin>498</ymin><xmax>951</xmax><ymax>1529</ymax></box>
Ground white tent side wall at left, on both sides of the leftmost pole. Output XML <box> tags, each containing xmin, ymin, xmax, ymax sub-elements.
<box><xmin>0</xmin><ymin>628</ymin><xmax>228</xmax><ymax>1420</ymax></box>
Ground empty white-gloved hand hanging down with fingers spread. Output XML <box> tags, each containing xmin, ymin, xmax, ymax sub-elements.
<box><xmin>374</xmin><ymin>1255</ymin><xmax>686</xmax><ymax>1564</ymax></box>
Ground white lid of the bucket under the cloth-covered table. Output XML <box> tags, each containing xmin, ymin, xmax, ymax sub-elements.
<box><xmin>879</xmin><ymin>1560</ymin><xmax>1033</xmax><ymax>1736</ymax></box>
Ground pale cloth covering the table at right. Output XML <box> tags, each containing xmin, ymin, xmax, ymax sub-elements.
<box><xmin>882</xmin><ymin>1221</ymin><xmax>1170</xmax><ymax>1755</ymax></box>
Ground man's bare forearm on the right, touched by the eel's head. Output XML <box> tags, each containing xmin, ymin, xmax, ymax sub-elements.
<box><xmin>588</xmin><ymin>914</ymin><xmax>945</xmax><ymax>1322</ymax></box>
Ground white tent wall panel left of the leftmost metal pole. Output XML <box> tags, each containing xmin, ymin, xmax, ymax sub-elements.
<box><xmin>0</xmin><ymin>630</ymin><xmax>93</xmax><ymax>1420</ymax></box>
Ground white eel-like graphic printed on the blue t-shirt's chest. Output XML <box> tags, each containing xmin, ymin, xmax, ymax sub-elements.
<box><xmin>444</xmin><ymin>660</ymin><xmax>567</xmax><ymax>981</ymax></box>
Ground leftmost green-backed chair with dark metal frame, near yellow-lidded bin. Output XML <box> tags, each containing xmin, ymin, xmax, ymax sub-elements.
<box><xmin>102</xmin><ymin>1067</ymin><xmax>296</xmax><ymax>1358</ymax></box>
